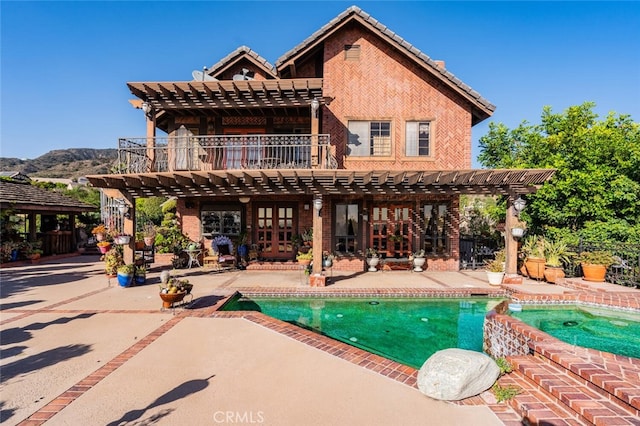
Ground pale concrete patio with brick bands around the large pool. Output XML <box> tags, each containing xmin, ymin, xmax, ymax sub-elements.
<box><xmin>0</xmin><ymin>256</ymin><xmax>638</xmax><ymax>425</ymax></box>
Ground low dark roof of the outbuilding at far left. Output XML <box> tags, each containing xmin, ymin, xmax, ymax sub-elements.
<box><xmin>0</xmin><ymin>180</ymin><xmax>98</xmax><ymax>213</ymax></box>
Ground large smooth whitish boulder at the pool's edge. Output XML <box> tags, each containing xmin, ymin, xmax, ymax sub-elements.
<box><xmin>418</xmin><ymin>348</ymin><xmax>500</xmax><ymax>401</ymax></box>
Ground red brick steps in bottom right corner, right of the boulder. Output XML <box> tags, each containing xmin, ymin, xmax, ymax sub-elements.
<box><xmin>505</xmin><ymin>356</ymin><xmax>640</xmax><ymax>425</ymax></box>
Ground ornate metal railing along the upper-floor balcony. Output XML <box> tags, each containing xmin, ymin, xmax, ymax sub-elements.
<box><xmin>118</xmin><ymin>134</ymin><xmax>337</xmax><ymax>173</ymax></box>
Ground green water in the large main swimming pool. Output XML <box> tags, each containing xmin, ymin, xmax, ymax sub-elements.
<box><xmin>224</xmin><ymin>297</ymin><xmax>501</xmax><ymax>368</ymax></box>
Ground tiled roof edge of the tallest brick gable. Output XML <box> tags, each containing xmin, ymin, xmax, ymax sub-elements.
<box><xmin>276</xmin><ymin>6</ymin><xmax>496</xmax><ymax>123</ymax></box>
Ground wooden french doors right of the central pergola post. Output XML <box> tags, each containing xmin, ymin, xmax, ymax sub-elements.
<box><xmin>369</xmin><ymin>204</ymin><xmax>413</xmax><ymax>257</ymax></box>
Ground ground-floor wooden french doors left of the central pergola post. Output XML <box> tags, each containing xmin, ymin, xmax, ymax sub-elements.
<box><xmin>254</xmin><ymin>203</ymin><xmax>298</xmax><ymax>260</ymax></box>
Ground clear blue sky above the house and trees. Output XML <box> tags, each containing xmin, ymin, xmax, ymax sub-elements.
<box><xmin>0</xmin><ymin>0</ymin><xmax>640</xmax><ymax>167</ymax></box>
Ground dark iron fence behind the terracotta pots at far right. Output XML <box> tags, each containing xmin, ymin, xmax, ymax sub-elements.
<box><xmin>564</xmin><ymin>243</ymin><xmax>640</xmax><ymax>288</ymax></box>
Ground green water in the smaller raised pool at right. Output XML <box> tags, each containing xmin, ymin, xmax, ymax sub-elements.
<box><xmin>511</xmin><ymin>305</ymin><xmax>640</xmax><ymax>358</ymax></box>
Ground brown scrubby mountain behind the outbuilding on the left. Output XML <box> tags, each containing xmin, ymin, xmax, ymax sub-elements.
<box><xmin>0</xmin><ymin>148</ymin><xmax>118</xmax><ymax>179</ymax></box>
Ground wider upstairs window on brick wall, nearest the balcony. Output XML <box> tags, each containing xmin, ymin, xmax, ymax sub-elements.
<box><xmin>347</xmin><ymin>121</ymin><xmax>391</xmax><ymax>157</ymax></box>
